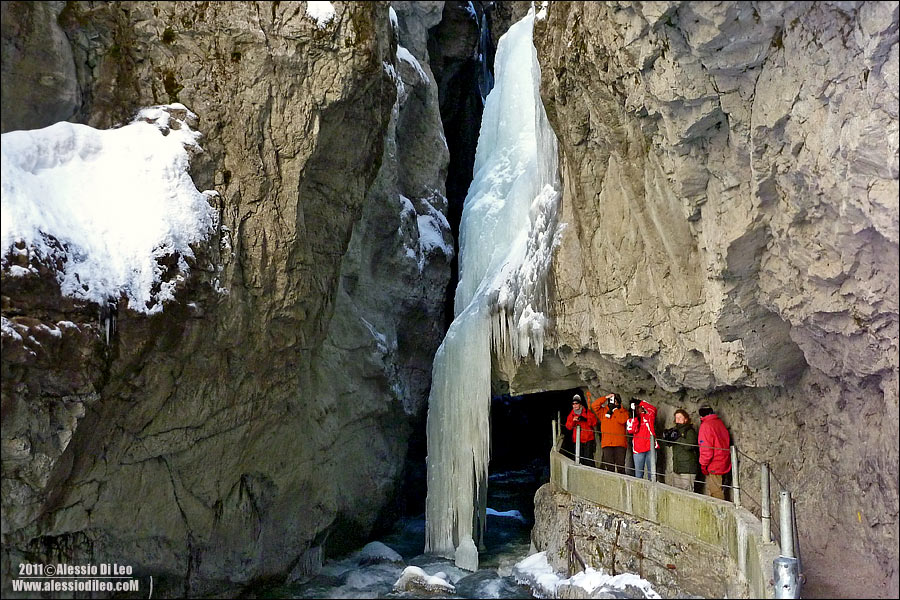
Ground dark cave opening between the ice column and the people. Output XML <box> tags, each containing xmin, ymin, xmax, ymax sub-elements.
<box><xmin>480</xmin><ymin>388</ymin><xmax>583</xmax><ymax>565</ymax></box>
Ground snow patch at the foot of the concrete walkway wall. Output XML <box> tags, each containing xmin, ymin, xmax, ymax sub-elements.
<box><xmin>513</xmin><ymin>552</ymin><xmax>660</xmax><ymax>598</ymax></box>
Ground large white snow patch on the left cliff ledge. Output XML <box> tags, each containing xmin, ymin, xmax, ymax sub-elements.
<box><xmin>0</xmin><ymin>104</ymin><xmax>216</xmax><ymax>313</ymax></box>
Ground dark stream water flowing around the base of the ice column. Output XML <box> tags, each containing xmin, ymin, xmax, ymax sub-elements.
<box><xmin>259</xmin><ymin>464</ymin><xmax>547</xmax><ymax>598</ymax></box>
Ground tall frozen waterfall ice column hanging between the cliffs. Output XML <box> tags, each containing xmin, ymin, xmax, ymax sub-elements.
<box><xmin>425</xmin><ymin>11</ymin><xmax>560</xmax><ymax>570</ymax></box>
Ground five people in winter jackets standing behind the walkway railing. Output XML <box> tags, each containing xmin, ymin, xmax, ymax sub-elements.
<box><xmin>566</xmin><ymin>392</ymin><xmax>731</xmax><ymax>500</ymax></box>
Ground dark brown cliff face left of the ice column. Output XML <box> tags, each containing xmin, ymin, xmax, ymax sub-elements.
<box><xmin>2</xmin><ymin>2</ymin><xmax>452</xmax><ymax>595</ymax></box>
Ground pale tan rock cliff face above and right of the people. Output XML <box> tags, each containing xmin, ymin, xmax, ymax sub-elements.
<box><xmin>524</xmin><ymin>2</ymin><xmax>900</xmax><ymax>596</ymax></box>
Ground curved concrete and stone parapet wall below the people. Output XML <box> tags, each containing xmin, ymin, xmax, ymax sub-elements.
<box><xmin>533</xmin><ymin>451</ymin><xmax>779</xmax><ymax>598</ymax></box>
